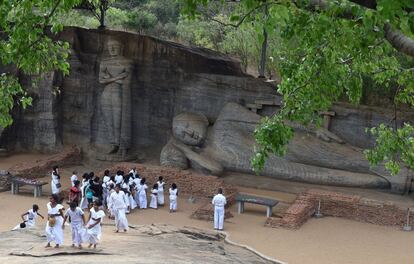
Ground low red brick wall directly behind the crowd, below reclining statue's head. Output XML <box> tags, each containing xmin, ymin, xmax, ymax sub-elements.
<box><xmin>99</xmin><ymin>162</ymin><xmax>237</xmax><ymax>220</ymax></box>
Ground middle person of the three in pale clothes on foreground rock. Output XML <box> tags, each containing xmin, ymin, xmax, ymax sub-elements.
<box><xmin>62</xmin><ymin>202</ymin><xmax>85</xmax><ymax>249</ymax></box>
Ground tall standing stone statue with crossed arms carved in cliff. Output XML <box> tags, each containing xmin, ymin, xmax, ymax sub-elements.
<box><xmin>99</xmin><ymin>39</ymin><xmax>132</xmax><ymax>158</ymax></box>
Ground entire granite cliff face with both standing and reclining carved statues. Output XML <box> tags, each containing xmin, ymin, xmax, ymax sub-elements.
<box><xmin>0</xmin><ymin>28</ymin><xmax>414</xmax><ymax>191</ymax></box>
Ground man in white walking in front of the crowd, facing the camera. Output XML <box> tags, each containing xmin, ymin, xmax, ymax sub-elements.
<box><xmin>109</xmin><ymin>184</ymin><xmax>128</xmax><ymax>233</ymax></box>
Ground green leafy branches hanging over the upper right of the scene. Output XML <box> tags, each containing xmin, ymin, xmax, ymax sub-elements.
<box><xmin>183</xmin><ymin>0</ymin><xmax>414</xmax><ymax>173</ymax></box>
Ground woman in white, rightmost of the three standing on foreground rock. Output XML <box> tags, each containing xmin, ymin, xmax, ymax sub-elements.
<box><xmin>85</xmin><ymin>201</ymin><xmax>105</xmax><ymax>248</ymax></box>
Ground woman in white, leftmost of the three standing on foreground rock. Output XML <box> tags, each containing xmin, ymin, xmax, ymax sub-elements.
<box><xmin>45</xmin><ymin>194</ymin><xmax>65</xmax><ymax>248</ymax></box>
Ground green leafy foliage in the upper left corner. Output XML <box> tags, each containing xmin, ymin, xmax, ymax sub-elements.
<box><xmin>0</xmin><ymin>0</ymin><xmax>79</xmax><ymax>127</ymax></box>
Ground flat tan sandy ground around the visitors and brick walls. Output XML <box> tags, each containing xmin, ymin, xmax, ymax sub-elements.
<box><xmin>0</xmin><ymin>155</ymin><xmax>414</xmax><ymax>264</ymax></box>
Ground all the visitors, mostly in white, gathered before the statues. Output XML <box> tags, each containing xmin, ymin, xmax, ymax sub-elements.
<box><xmin>15</xmin><ymin>167</ymin><xmax>227</xmax><ymax>248</ymax></box>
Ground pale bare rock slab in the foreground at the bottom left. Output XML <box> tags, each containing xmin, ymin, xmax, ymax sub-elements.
<box><xmin>0</xmin><ymin>225</ymin><xmax>274</xmax><ymax>264</ymax></box>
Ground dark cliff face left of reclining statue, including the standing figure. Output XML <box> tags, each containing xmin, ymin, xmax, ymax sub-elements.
<box><xmin>0</xmin><ymin>28</ymin><xmax>276</xmax><ymax>155</ymax></box>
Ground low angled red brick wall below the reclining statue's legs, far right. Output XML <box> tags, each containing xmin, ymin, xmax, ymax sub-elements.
<box><xmin>265</xmin><ymin>189</ymin><xmax>414</xmax><ymax>229</ymax></box>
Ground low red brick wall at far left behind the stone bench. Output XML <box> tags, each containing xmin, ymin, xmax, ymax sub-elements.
<box><xmin>9</xmin><ymin>146</ymin><xmax>82</xmax><ymax>178</ymax></box>
